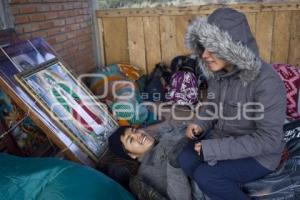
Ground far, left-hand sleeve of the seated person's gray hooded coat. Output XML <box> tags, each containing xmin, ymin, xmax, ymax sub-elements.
<box><xmin>194</xmin><ymin>79</ymin><xmax>218</xmax><ymax>132</ymax></box>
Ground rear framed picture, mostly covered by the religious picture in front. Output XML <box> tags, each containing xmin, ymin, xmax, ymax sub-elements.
<box><xmin>0</xmin><ymin>38</ymin><xmax>115</xmax><ymax>167</ymax></box>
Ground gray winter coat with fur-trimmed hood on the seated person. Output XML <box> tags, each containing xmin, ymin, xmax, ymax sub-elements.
<box><xmin>186</xmin><ymin>8</ymin><xmax>286</xmax><ymax>170</ymax></box>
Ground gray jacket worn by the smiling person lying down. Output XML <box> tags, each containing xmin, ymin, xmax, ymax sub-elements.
<box><xmin>138</xmin><ymin>122</ymin><xmax>192</xmax><ymax>200</ymax></box>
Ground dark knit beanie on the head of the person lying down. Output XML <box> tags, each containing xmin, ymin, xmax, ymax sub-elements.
<box><xmin>108</xmin><ymin>126</ymin><xmax>133</xmax><ymax>160</ymax></box>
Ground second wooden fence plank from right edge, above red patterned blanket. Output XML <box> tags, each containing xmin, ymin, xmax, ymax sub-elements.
<box><xmin>271</xmin><ymin>11</ymin><xmax>291</xmax><ymax>63</ymax></box>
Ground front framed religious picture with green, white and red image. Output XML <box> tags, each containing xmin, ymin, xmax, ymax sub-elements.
<box><xmin>15</xmin><ymin>61</ymin><xmax>118</xmax><ymax>161</ymax></box>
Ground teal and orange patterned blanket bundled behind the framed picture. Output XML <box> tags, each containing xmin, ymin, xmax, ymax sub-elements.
<box><xmin>90</xmin><ymin>64</ymin><xmax>158</xmax><ymax>126</ymax></box>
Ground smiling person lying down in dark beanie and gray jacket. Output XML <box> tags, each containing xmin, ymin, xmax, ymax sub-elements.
<box><xmin>109</xmin><ymin>122</ymin><xmax>192</xmax><ymax>200</ymax></box>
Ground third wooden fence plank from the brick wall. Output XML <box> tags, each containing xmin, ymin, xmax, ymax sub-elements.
<box><xmin>143</xmin><ymin>17</ymin><xmax>161</xmax><ymax>74</ymax></box>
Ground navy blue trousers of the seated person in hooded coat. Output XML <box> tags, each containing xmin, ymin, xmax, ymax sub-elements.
<box><xmin>179</xmin><ymin>142</ymin><xmax>271</xmax><ymax>200</ymax></box>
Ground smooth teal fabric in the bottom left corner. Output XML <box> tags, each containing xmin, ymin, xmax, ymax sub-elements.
<box><xmin>0</xmin><ymin>153</ymin><xmax>134</xmax><ymax>200</ymax></box>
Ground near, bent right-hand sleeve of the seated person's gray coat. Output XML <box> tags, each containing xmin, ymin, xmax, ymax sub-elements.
<box><xmin>201</xmin><ymin>77</ymin><xmax>286</xmax><ymax>162</ymax></box>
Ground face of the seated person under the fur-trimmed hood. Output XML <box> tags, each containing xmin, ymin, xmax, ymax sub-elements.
<box><xmin>202</xmin><ymin>49</ymin><xmax>230</xmax><ymax>72</ymax></box>
